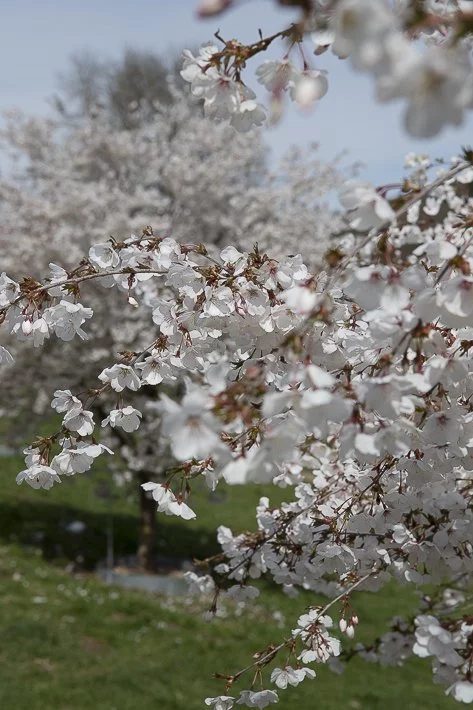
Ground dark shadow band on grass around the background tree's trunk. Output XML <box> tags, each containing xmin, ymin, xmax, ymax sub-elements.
<box><xmin>0</xmin><ymin>501</ymin><xmax>219</xmax><ymax>570</ymax></box>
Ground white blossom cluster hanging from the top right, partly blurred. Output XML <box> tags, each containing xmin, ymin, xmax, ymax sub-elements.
<box><xmin>181</xmin><ymin>0</ymin><xmax>473</xmax><ymax>138</ymax></box>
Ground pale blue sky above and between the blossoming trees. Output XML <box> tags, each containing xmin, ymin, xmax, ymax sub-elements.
<box><xmin>0</xmin><ymin>0</ymin><xmax>473</xmax><ymax>184</ymax></box>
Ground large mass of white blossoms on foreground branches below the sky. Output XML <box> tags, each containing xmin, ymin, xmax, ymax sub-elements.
<box><xmin>4</xmin><ymin>153</ymin><xmax>473</xmax><ymax>707</ymax></box>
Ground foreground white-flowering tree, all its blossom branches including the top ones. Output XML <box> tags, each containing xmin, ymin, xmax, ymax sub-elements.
<box><xmin>4</xmin><ymin>0</ymin><xmax>473</xmax><ymax>710</ymax></box>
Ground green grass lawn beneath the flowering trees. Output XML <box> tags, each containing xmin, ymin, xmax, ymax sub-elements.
<box><xmin>0</xmin><ymin>458</ymin><xmax>457</xmax><ymax>710</ymax></box>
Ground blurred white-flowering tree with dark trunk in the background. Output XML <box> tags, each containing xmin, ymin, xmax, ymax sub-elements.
<box><xmin>0</xmin><ymin>62</ymin><xmax>341</xmax><ymax>570</ymax></box>
